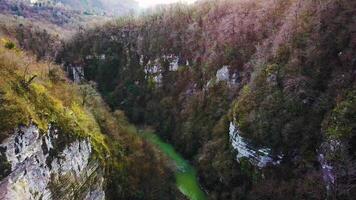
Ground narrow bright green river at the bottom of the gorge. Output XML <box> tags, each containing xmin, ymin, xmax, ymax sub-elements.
<box><xmin>143</xmin><ymin>132</ymin><xmax>206</xmax><ymax>200</ymax></box>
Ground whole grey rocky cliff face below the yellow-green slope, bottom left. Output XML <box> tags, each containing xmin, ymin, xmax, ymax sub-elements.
<box><xmin>0</xmin><ymin>125</ymin><xmax>105</xmax><ymax>199</ymax></box>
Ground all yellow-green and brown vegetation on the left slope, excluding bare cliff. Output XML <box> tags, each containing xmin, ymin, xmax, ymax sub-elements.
<box><xmin>0</xmin><ymin>38</ymin><xmax>177</xmax><ymax>199</ymax></box>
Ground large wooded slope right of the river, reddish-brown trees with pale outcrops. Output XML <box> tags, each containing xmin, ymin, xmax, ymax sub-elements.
<box><xmin>57</xmin><ymin>0</ymin><xmax>356</xmax><ymax>199</ymax></box>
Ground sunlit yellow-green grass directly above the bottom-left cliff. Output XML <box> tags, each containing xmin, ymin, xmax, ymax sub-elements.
<box><xmin>0</xmin><ymin>39</ymin><xmax>128</xmax><ymax>164</ymax></box>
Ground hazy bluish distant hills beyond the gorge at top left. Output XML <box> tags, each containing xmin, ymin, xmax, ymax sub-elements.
<box><xmin>0</xmin><ymin>0</ymin><xmax>137</xmax><ymax>37</ymax></box>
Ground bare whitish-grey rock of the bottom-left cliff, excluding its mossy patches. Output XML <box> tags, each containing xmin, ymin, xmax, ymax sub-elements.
<box><xmin>0</xmin><ymin>125</ymin><xmax>105</xmax><ymax>200</ymax></box>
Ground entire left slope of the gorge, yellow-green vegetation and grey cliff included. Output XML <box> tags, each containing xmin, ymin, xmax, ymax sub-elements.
<box><xmin>0</xmin><ymin>38</ymin><xmax>179</xmax><ymax>199</ymax></box>
